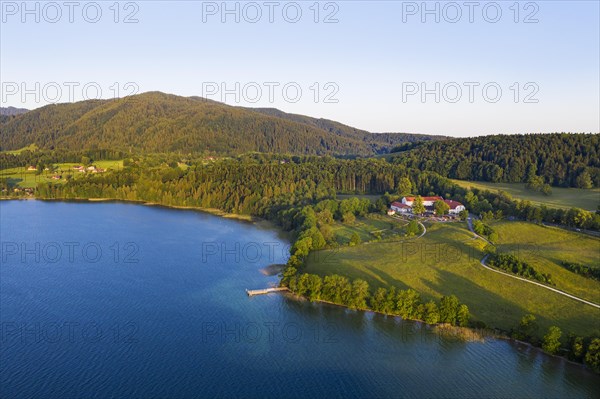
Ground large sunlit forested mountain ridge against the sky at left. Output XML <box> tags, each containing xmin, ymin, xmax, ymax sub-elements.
<box><xmin>0</xmin><ymin>92</ymin><xmax>440</xmax><ymax>156</ymax></box>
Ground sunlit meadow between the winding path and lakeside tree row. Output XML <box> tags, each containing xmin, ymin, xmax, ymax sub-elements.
<box><xmin>306</xmin><ymin>223</ymin><xmax>600</xmax><ymax>335</ymax></box>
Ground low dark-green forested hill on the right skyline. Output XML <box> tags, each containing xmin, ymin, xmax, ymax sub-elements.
<box><xmin>390</xmin><ymin>133</ymin><xmax>600</xmax><ymax>188</ymax></box>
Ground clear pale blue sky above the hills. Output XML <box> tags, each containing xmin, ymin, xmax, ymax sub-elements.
<box><xmin>0</xmin><ymin>1</ymin><xmax>600</xmax><ymax>136</ymax></box>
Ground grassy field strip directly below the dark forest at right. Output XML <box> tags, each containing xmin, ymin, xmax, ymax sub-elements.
<box><xmin>452</xmin><ymin>180</ymin><xmax>600</xmax><ymax>211</ymax></box>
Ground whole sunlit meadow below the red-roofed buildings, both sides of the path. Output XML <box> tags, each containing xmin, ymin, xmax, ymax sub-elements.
<box><xmin>303</xmin><ymin>223</ymin><xmax>600</xmax><ymax>335</ymax></box>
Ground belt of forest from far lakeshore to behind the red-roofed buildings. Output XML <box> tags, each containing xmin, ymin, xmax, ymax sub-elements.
<box><xmin>16</xmin><ymin>153</ymin><xmax>600</xmax><ymax>230</ymax></box>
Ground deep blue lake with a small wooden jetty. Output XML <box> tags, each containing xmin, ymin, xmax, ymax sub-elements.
<box><xmin>0</xmin><ymin>201</ymin><xmax>600</xmax><ymax>398</ymax></box>
